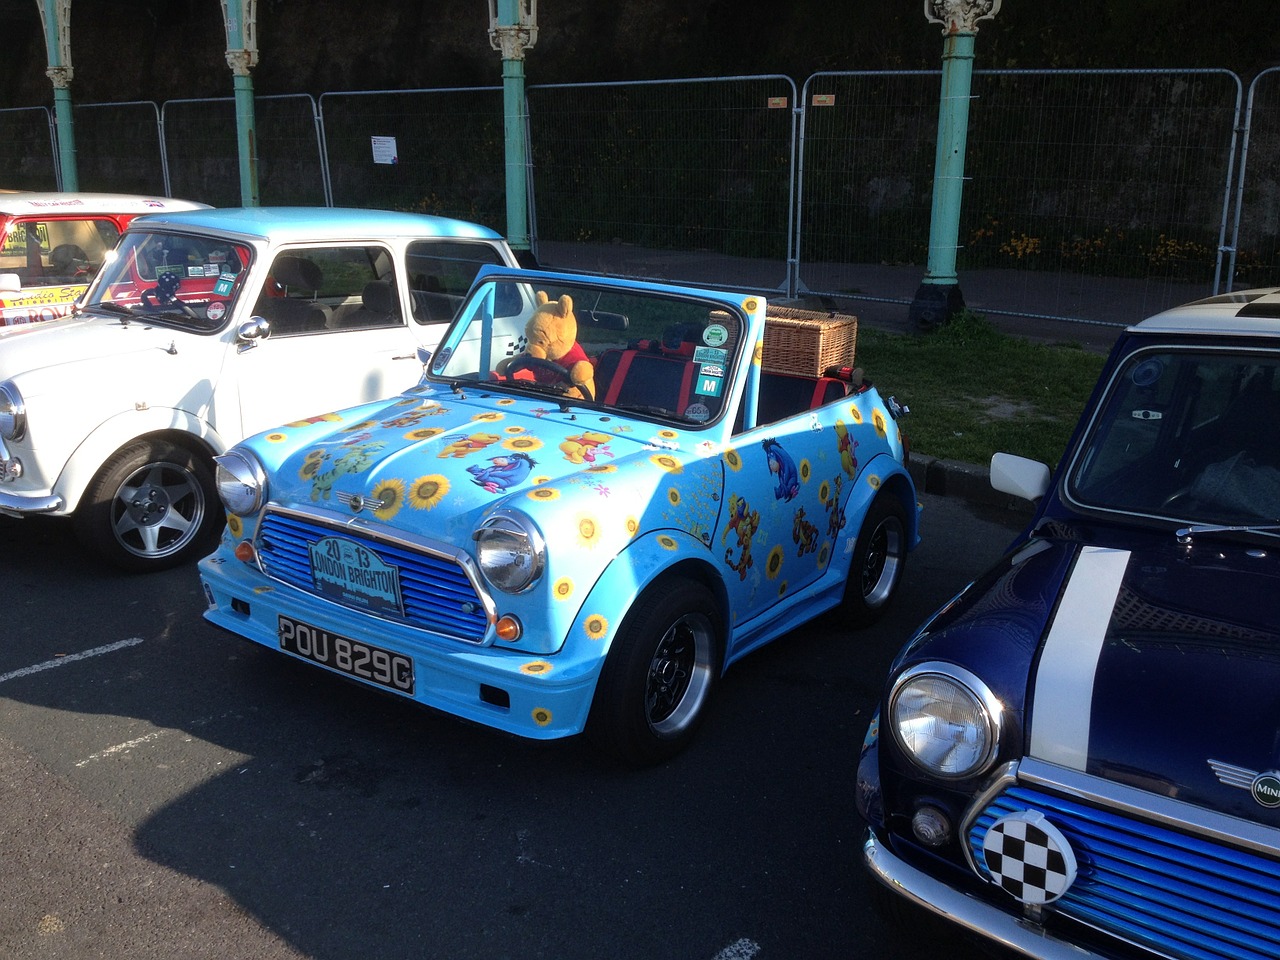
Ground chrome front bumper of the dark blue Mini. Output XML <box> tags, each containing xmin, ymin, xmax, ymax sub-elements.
<box><xmin>863</xmin><ymin>832</ymin><xmax>1101</xmax><ymax>960</ymax></box>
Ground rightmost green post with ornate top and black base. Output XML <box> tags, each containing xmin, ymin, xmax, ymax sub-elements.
<box><xmin>908</xmin><ymin>0</ymin><xmax>1000</xmax><ymax>330</ymax></box>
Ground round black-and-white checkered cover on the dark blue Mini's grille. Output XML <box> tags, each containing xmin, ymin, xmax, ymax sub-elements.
<box><xmin>982</xmin><ymin>810</ymin><xmax>1076</xmax><ymax>904</ymax></box>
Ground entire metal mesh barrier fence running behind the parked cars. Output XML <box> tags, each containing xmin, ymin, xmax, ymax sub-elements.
<box><xmin>17</xmin><ymin>68</ymin><xmax>1280</xmax><ymax>323</ymax></box>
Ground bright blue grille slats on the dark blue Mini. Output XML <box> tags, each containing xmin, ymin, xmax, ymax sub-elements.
<box><xmin>969</xmin><ymin>786</ymin><xmax>1280</xmax><ymax>960</ymax></box>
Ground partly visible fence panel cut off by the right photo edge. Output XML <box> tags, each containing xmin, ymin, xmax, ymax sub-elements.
<box><xmin>1228</xmin><ymin>67</ymin><xmax>1280</xmax><ymax>289</ymax></box>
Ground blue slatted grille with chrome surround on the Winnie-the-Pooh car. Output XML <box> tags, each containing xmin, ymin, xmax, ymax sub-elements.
<box><xmin>253</xmin><ymin>506</ymin><xmax>495</xmax><ymax>645</ymax></box>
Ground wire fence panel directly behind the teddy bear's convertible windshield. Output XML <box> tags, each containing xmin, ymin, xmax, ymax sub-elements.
<box><xmin>529</xmin><ymin>77</ymin><xmax>796</xmax><ymax>289</ymax></box>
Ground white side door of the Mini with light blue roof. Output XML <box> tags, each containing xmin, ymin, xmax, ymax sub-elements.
<box><xmin>232</xmin><ymin>243</ymin><xmax>434</xmax><ymax>435</ymax></box>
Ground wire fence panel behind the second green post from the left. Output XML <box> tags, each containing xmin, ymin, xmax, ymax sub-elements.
<box><xmin>161</xmin><ymin>93</ymin><xmax>325</xmax><ymax>206</ymax></box>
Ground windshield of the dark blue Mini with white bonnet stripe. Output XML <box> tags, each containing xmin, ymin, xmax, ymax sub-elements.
<box><xmin>1066</xmin><ymin>349</ymin><xmax>1280</xmax><ymax>525</ymax></box>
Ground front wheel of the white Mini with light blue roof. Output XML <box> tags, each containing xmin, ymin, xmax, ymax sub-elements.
<box><xmin>74</xmin><ymin>439</ymin><xmax>223</xmax><ymax>573</ymax></box>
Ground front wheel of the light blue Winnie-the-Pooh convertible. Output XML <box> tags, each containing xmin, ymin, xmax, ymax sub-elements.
<box><xmin>586</xmin><ymin>577</ymin><xmax>724</xmax><ymax>767</ymax></box>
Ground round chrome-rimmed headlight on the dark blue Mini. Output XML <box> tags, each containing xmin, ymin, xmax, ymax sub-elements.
<box><xmin>888</xmin><ymin>663</ymin><xmax>1002</xmax><ymax>778</ymax></box>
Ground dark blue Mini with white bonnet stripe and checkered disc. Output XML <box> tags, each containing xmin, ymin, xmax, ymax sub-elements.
<box><xmin>858</xmin><ymin>291</ymin><xmax>1280</xmax><ymax>960</ymax></box>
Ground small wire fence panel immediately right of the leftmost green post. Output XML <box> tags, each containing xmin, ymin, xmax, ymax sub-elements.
<box><xmin>74</xmin><ymin>101</ymin><xmax>169</xmax><ymax>197</ymax></box>
